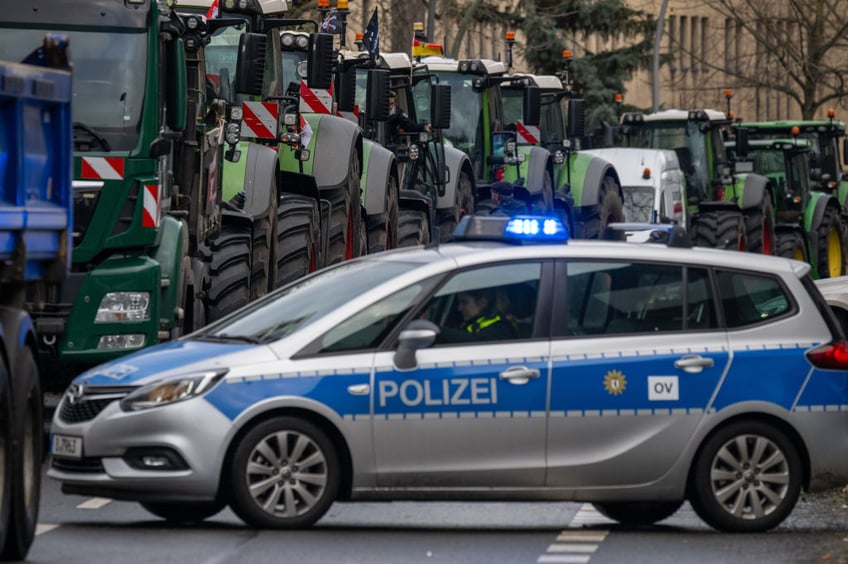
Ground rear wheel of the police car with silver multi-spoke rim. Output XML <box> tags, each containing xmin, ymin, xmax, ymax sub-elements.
<box><xmin>689</xmin><ymin>421</ymin><xmax>802</xmax><ymax>533</ymax></box>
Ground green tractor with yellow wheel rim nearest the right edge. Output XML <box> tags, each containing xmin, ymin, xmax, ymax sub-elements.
<box><xmin>726</xmin><ymin>133</ymin><xmax>846</xmax><ymax>278</ymax></box>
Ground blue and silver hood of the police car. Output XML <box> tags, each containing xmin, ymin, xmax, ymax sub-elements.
<box><xmin>74</xmin><ymin>340</ymin><xmax>277</xmax><ymax>386</ymax></box>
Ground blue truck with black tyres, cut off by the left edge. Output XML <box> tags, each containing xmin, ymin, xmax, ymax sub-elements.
<box><xmin>0</xmin><ymin>36</ymin><xmax>73</xmax><ymax>560</ymax></box>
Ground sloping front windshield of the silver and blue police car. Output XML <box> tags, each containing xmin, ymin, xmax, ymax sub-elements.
<box><xmin>191</xmin><ymin>260</ymin><xmax>420</xmax><ymax>342</ymax></box>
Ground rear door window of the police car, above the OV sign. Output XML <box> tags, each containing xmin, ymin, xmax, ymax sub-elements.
<box><xmin>566</xmin><ymin>262</ymin><xmax>688</xmax><ymax>335</ymax></box>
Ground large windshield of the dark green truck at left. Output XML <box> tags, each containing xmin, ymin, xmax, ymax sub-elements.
<box><xmin>0</xmin><ymin>27</ymin><xmax>147</xmax><ymax>151</ymax></box>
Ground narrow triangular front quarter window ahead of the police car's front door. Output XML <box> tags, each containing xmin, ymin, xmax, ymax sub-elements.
<box><xmin>320</xmin><ymin>283</ymin><xmax>432</xmax><ymax>353</ymax></box>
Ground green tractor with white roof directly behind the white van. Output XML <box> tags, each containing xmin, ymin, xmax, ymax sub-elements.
<box><xmin>619</xmin><ymin>110</ymin><xmax>776</xmax><ymax>254</ymax></box>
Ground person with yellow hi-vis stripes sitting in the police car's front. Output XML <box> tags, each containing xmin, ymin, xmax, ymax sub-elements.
<box><xmin>441</xmin><ymin>288</ymin><xmax>518</xmax><ymax>343</ymax></box>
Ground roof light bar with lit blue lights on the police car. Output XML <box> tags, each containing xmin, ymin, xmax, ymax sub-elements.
<box><xmin>453</xmin><ymin>215</ymin><xmax>569</xmax><ymax>244</ymax></box>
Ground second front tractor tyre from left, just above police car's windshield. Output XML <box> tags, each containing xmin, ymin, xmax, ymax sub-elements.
<box><xmin>274</xmin><ymin>194</ymin><xmax>321</xmax><ymax>288</ymax></box>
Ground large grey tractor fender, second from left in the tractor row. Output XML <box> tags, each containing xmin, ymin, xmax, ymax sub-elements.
<box><xmin>312</xmin><ymin>114</ymin><xmax>362</xmax><ymax>191</ymax></box>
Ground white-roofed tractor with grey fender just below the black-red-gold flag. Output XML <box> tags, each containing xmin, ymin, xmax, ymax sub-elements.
<box><xmin>339</xmin><ymin>52</ymin><xmax>474</xmax><ymax>246</ymax></box>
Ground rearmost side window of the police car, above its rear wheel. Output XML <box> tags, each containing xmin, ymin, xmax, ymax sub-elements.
<box><xmin>716</xmin><ymin>270</ymin><xmax>792</xmax><ymax>328</ymax></box>
